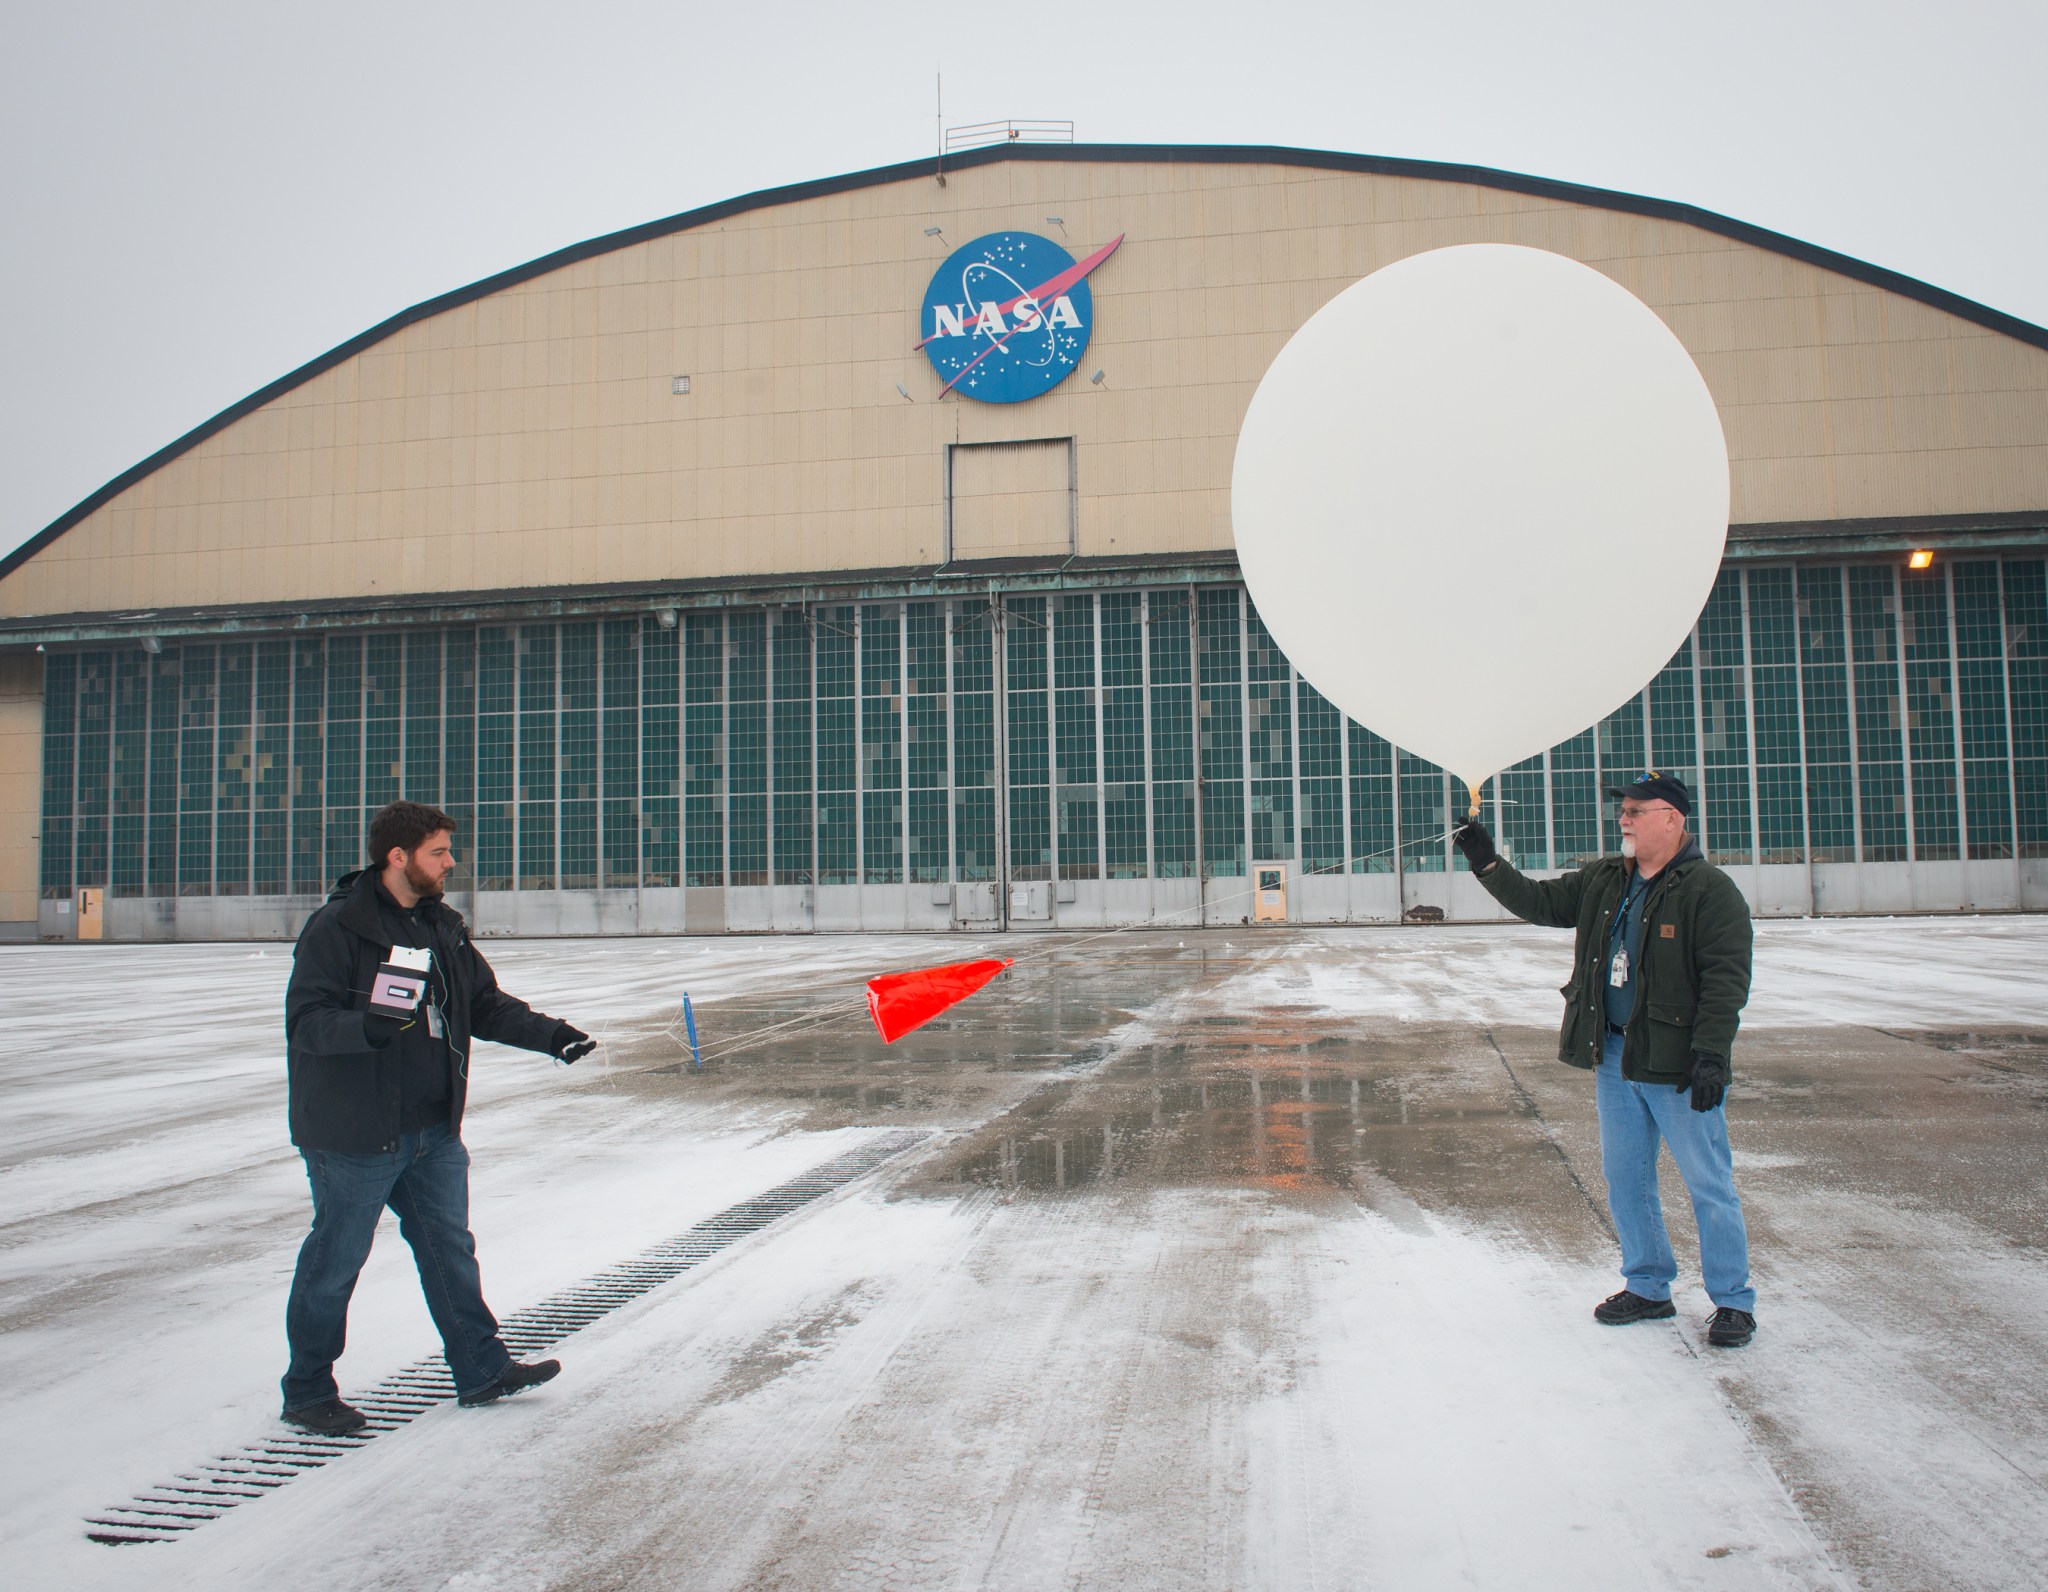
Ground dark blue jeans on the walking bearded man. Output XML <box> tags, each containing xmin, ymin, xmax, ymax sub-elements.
<box><xmin>285</xmin><ymin>1123</ymin><xmax>512</xmax><ymax>1410</ymax></box>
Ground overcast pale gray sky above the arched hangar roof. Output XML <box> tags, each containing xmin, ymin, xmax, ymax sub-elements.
<box><xmin>0</xmin><ymin>0</ymin><xmax>2048</xmax><ymax>549</ymax></box>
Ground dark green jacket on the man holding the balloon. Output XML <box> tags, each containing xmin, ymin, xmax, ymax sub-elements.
<box><xmin>1479</xmin><ymin>840</ymin><xmax>1751</xmax><ymax>1086</ymax></box>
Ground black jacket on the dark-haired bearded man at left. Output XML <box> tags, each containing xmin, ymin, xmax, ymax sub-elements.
<box><xmin>285</xmin><ymin>869</ymin><xmax>559</xmax><ymax>1156</ymax></box>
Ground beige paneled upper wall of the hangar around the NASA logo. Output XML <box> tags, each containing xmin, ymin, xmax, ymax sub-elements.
<box><xmin>0</xmin><ymin>145</ymin><xmax>2048</xmax><ymax>621</ymax></box>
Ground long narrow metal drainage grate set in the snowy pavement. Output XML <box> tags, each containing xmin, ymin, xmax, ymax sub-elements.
<box><xmin>86</xmin><ymin>1129</ymin><xmax>932</xmax><ymax>1545</ymax></box>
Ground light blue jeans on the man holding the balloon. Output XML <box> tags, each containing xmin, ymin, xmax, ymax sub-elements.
<box><xmin>1593</xmin><ymin>1035</ymin><xmax>1757</xmax><ymax>1311</ymax></box>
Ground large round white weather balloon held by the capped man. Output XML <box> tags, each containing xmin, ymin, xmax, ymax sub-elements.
<box><xmin>1231</xmin><ymin>244</ymin><xmax>1729</xmax><ymax>789</ymax></box>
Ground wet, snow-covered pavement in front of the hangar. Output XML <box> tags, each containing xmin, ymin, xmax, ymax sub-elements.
<box><xmin>0</xmin><ymin>918</ymin><xmax>2048</xmax><ymax>1588</ymax></box>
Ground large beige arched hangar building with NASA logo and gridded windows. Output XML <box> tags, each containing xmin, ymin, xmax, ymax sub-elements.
<box><xmin>0</xmin><ymin>145</ymin><xmax>2048</xmax><ymax>940</ymax></box>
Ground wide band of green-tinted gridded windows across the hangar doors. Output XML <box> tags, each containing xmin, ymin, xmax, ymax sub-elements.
<box><xmin>28</xmin><ymin>557</ymin><xmax>2048</xmax><ymax>897</ymax></box>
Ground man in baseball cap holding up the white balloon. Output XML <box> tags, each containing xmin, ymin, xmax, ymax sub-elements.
<box><xmin>1452</xmin><ymin>770</ymin><xmax>1757</xmax><ymax>1348</ymax></box>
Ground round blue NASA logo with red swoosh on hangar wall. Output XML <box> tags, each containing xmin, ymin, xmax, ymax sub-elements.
<box><xmin>918</xmin><ymin>232</ymin><xmax>1124</xmax><ymax>404</ymax></box>
